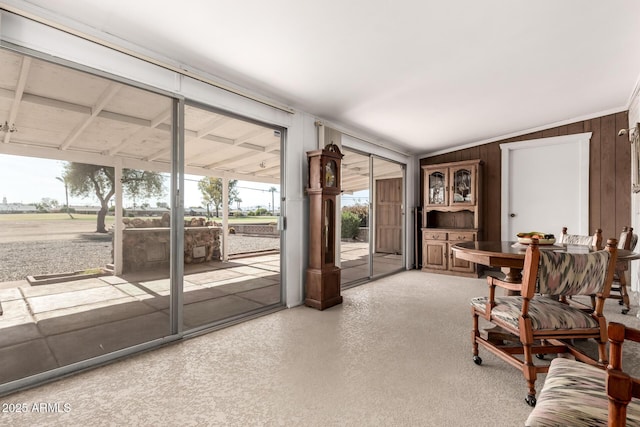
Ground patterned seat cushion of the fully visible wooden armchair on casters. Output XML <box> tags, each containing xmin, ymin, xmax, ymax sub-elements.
<box><xmin>471</xmin><ymin>296</ymin><xmax>598</xmax><ymax>331</ymax></box>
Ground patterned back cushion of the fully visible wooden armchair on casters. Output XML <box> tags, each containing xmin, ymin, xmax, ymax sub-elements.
<box><xmin>537</xmin><ymin>250</ymin><xmax>611</xmax><ymax>296</ymax></box>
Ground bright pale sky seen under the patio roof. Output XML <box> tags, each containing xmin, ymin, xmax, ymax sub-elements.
<box><xmin>0</xmin><ymin>154</ymin><xmax>280</xmax><ymax>210</ymax></box>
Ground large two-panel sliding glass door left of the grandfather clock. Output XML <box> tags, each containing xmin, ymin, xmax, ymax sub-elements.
<box><xmin>0</xmin><ymin>49</ymin><xmax>285</xmax><ymax>393</ymax></box>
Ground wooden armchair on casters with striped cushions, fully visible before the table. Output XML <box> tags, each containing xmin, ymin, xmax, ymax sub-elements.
<box><xmin>471</xmin><ymin>239</ymin><xmax>618</xmax><ymax>406</ymax></box>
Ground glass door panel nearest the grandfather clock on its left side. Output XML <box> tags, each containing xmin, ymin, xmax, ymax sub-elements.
<box><xmin>183</xmin><ymin>105</ymin><xmax>282</xmax><ymax>330</ymax></box>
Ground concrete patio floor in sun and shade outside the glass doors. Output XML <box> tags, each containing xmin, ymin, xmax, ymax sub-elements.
<box><xmin>0</xmin><ymin>242</ymin><xmax>402</xmax><ymax>384</ymax></box>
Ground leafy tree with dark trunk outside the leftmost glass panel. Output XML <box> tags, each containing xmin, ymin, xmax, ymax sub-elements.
<box><xmin>63</xmin><ymin>162</ymin><xmax>164</xmax><ymax>233</ymax></box>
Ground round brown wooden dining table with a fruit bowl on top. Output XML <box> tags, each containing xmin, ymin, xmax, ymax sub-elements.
<box><xmin>451</xmin><ymin>241</ymin><xmax>640</xmax><ymax>283</ymax></box>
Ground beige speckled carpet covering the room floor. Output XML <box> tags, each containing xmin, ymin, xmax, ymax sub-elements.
<box><xmin>0</xmin><ymin>271</ymin><xmax>640</xmax><ymax>427</ymax></box>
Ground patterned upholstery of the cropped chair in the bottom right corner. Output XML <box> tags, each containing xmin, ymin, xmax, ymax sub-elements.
<box><xmin>525</xmin><ymin>358</ymin><xmax>640</xmax><ymax>427</ymax></box>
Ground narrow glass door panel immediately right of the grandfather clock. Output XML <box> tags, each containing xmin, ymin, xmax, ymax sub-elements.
<box><xmin>340</xmin><ymin>147</ymin><xmax>371</xmax><ymax>285</ymax></box>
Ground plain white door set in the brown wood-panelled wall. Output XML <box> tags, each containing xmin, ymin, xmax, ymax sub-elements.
<box><xmin>500</xmin><ymin>132</ymin><xmax>591</xmax><ymax>241</ymax></box>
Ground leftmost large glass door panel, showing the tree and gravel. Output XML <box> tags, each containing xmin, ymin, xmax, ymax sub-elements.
<box><xmin>0</xmin><ymin>50</ymin><xmax>172</xmax><ymax>385</ymax></box>
